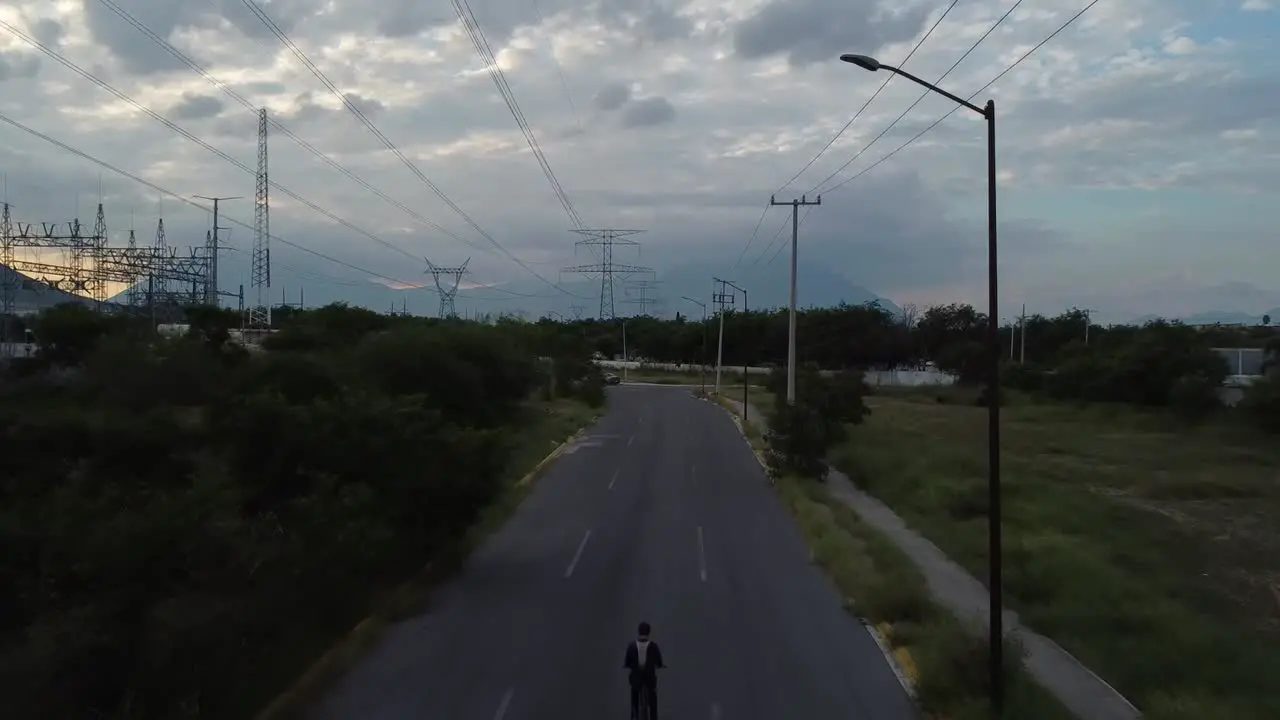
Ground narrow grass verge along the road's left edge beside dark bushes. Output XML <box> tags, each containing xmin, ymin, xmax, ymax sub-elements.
<box><xmin>256</xmin><ymin>400</ymin><xmax>599</xmax><ymax>720</ymax></box>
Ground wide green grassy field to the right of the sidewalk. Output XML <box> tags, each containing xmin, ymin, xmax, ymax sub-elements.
<box><xmin>833</xmin><ymin>388</ymin><xmax>1280</xmax><ymax>720</ymax></box>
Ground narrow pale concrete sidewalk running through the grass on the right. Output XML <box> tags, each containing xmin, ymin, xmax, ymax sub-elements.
<box><xmin>724</xmin><ymin>397</ymin><xmax>1142</xmax><ymax>720</ymax></box>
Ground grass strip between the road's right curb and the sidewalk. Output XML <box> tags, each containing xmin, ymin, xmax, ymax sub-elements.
<box><xmin>726</xmin><ymin>392</ymin><xmax>1073</xmax><ymax>720</ymax></box>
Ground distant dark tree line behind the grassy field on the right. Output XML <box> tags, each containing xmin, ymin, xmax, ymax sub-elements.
<box><xmin>540</xmin><ymin>304</ymin><xmax>1280</xmax><ymax>425</ymax></box>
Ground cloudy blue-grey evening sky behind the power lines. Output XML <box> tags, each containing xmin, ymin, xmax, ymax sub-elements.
<box><xmin>0</xmin><ymin>0</ymin><xmax>1280</xmax><ymax>319</ymax></box>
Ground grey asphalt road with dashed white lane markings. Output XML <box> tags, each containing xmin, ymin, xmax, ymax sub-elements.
<box><xmin>315</xmin><ymin>386</ymin><xmax>915</xmax><ymax>720</ymax></box>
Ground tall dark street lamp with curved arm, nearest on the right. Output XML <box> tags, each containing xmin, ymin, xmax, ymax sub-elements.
<box><xmin>840</xmin><ymin>54</ymin><xmax>1005</xmax><ymax>716</ymax></box>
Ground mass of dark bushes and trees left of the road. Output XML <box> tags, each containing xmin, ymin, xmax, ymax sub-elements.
<box><xmin>0</xmin><ymin>299</ymin><xmax>604</xmax><ymax>719</ymax></box>
